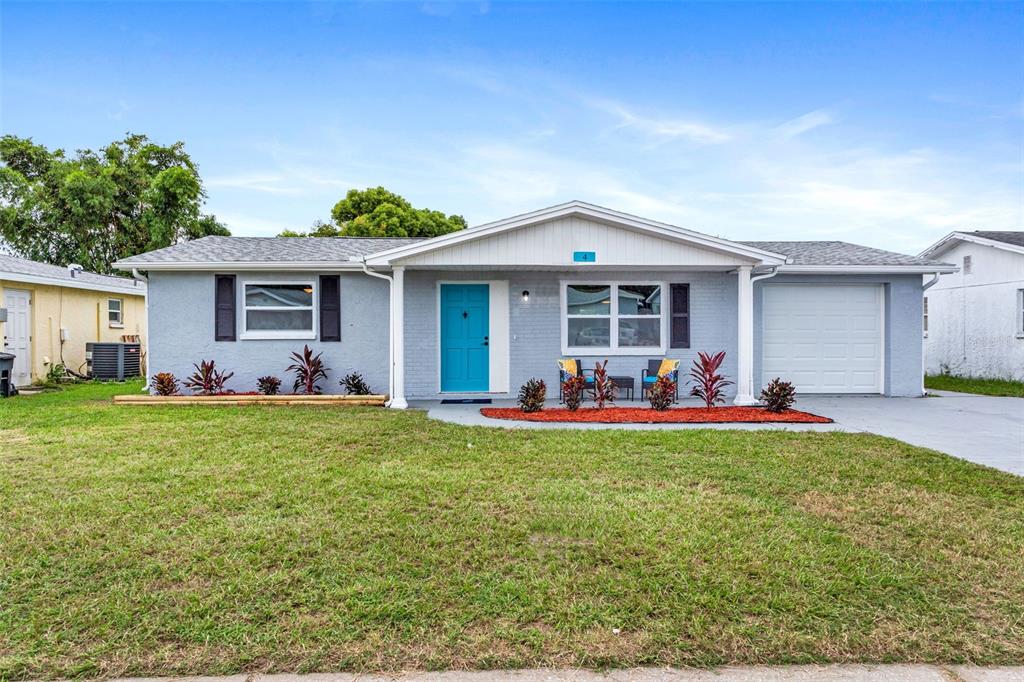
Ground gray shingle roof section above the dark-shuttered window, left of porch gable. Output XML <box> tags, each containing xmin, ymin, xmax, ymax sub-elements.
<box><xmin>118</xmin><ymin>237</ymin><xmax>421</xmax><ymax>266</ymax></box>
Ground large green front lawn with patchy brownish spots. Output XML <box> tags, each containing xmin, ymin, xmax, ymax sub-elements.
<box><xmin>0</xmin><ymin>384</ymin><xmax>1024</xmax><ymax>679</ymax></box>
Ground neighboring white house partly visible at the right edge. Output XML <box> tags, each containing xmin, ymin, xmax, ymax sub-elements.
<box><xmin>921</xmin><ymin>231</ymin><xmax>1024</xmax><ymax>380</ymax></box>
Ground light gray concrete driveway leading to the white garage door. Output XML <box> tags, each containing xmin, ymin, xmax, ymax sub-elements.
<box><xmin>796</xmin><ymin>391</ymin><xmax>1024</xmax><ymax>476</ymax></box>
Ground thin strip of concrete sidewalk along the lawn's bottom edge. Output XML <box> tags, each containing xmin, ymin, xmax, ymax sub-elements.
<box><xmin>105</xmin><ymin>665</ymin><xmax>1024</xmax><ymax>682</ymax></box>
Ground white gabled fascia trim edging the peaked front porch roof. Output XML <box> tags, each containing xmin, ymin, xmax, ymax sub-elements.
<box><xmin>366</xmin><ymin>197</ymin><xmax>785</xmax><ymax>265</ymax></box>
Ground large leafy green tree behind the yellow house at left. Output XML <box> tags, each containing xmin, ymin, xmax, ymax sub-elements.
<box><xmin>0</xmin><ymin>134</ymin><xmax>229</xmax><ymax>272</ymax></box>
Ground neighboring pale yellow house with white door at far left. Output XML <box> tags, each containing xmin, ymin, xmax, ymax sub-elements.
<box><xmin>0</xmin><ymin>254</ymin><xmax>146</xmax><ymax>386</ymax></box>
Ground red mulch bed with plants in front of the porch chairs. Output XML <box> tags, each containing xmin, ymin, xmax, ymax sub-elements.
<box><xmin>480</xmin><ymin>407</ymin><xmax>833</xmax><ymax>424</ymax></box>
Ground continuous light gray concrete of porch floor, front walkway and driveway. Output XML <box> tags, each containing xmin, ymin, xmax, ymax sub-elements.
<box><xmin>414</xmin><ymin>391</ymin><xmax>1024</xmax><ymax>476</ymax></box>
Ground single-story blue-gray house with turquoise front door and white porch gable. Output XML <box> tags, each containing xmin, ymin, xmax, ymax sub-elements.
<box><xmin>116</xmin><ymin>202</ymin><xmax>955</xmax><ymax>408</ymax></box>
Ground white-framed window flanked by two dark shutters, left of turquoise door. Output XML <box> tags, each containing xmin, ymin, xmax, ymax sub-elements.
<box><xmin>242</xmin><ymin>281</ymin><xmax>316</xmax><ymax>339</ymax></box>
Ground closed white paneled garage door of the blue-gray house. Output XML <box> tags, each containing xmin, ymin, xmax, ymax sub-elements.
<box><xmin>761</xmin><ymin>285</ymin><xmax>883</xmax><ymax>393</ymax></box>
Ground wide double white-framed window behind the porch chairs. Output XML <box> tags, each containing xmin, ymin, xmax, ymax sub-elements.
<box><xmin>562</xmin><ymin>282</ymin><xmax>666</xmax><ymax>354</ymax></box>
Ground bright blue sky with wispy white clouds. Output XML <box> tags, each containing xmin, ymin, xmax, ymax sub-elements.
<box><xmin>0</xmin><ymin>2</ymin><xmax>1024</xmax><ymax>252</ymax></box>
